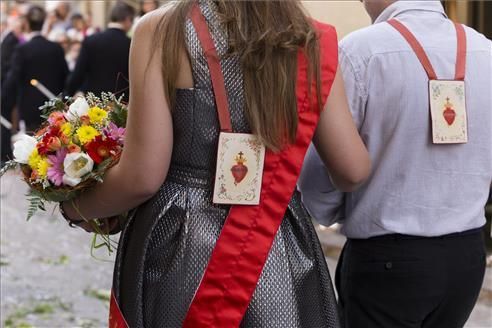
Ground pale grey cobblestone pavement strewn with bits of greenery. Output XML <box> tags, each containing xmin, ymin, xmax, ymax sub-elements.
<box><xmin>0</xmin><ymin>173</ymin><xmax>492</xmax><ymax>328</ymax></box>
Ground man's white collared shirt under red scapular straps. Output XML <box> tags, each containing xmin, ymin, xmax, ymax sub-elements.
<box><xmin>299</xmin><ymin>1</ymin><xmax>492</xmax><ymax>238</ymax></box>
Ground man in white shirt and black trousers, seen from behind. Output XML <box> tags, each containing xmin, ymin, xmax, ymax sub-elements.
<box><xmin>299</xmin><ymin>0</ymin><xmax>492</xmax><ymax>328</ymax></box>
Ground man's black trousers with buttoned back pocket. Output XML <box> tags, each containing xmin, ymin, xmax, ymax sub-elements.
<box><xmin>336</xmin><ymin>229</ymin><xmax>486</xmax><ymax>328</ymax></box>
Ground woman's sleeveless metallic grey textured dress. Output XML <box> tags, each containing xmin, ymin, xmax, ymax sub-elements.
<box><xmin>113</xmin><ymin>0</ymin><xmax>339</xmax><ymax>328</ymax></box>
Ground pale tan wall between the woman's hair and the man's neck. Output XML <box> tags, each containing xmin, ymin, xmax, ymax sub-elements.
<box><xmin>302</xmin><ymin>0</ymin><xmax>371</xmax><ymax>39</ymax></box>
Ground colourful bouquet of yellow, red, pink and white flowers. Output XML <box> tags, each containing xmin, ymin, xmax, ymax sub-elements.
<box><xmin>0</xmin><ymin>93</ymin><xmax>127</xmax><ymax>254</ymax></box>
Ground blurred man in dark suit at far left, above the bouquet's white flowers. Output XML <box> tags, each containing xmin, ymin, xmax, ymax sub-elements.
<box><xmin>1</xmin><ymin>6</ymin><xmax>68</xmax><ymax>132</ymax></box>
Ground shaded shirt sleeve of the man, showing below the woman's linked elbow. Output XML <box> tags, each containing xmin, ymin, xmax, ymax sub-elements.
<box><xmin>297</xmin><ymin>144</ymin><xmax>344</xmax><ymax>226</ymax></box>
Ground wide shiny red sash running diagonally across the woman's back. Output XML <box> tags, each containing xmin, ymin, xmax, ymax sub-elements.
<box><xmin>110</xmin><ymin>5</ymin><xmax>338</xmax><ymax>328</ymax></box>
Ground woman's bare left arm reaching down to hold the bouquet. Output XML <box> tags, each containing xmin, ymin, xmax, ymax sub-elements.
<box><xmin>63</xmin><ymin>15</ymin><xmax>173</xmax><ymax>223</ymax></box>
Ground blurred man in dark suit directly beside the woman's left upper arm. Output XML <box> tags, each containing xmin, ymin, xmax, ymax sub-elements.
<box><xmin>67</xmin><ymin>2</ymin><xmax>135</xmax><ymax>99</ymax></box>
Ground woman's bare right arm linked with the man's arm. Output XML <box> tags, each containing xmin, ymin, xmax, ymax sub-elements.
<box><xmin>313</xmin><ymin>65</ymin><xmax>371</xmax><ymax>192</ymax></box>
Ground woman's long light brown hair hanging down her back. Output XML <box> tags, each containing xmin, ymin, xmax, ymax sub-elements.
<box><xmin>154</xmin><ymin>0</ymin><xmax>322</xmax><ymax>151</ymax></box>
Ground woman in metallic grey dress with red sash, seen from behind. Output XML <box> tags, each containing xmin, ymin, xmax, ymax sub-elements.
<box><xmin>62</xmin><ymin>0</ymin><xmax>370</xmax><ymax>328</ymax></box>
